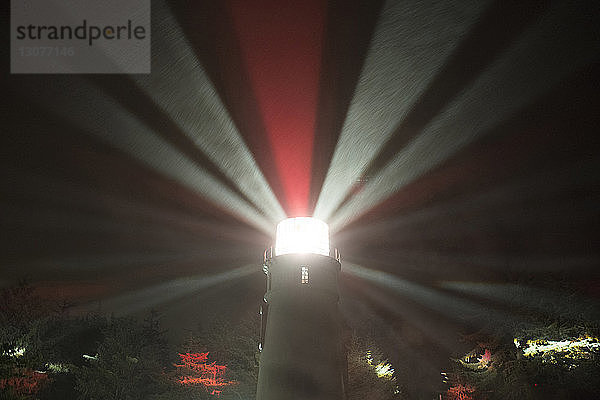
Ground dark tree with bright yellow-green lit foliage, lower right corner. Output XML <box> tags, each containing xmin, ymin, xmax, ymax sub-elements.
<box><xmin>447</xmin><ymin>322</ymin><xmax>600</xmax><ymax>400</ymax></box>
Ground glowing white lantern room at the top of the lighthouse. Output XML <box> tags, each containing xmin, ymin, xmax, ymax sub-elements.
<box><xmin>275</xmin><ymin>217</ymin><xmax>329</xmax><ymax>256</ymax></box>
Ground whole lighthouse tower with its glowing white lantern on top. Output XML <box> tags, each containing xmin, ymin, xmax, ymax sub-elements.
<box><xmin>257</xmin><ymin>217</ymin><xmax>347</xmax><ymax>400</ymax></box>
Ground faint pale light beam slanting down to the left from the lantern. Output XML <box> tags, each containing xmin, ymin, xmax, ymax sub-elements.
<box><xmin>73</xmin><ymin>265</ymin><xmax>260</xmax><ymax>315</ymax></box>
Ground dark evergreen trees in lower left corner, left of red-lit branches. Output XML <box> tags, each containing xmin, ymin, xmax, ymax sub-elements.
<box><xmin>0</xmin><ymin>284</ymin><xmax>190</xmax><ymax>400</ymax></box>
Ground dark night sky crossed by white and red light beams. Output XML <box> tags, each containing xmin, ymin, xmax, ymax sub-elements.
<box><xmin>0</xmin><ymin>0</ymin><xmax>600</xmax><ymax>394</ymax></box>
